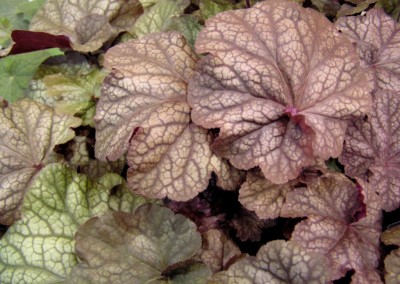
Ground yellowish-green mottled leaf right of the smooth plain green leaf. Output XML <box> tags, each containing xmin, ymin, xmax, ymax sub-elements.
<box><xmin>27</xmin><ymin>54</ymin><xmax>105</xmax><ymax>126</ymax></box>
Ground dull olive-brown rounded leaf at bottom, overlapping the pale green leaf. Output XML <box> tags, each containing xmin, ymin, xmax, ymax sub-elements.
<box><xmin>67</xmin><ymin>205</ymin><xmax>211</xmax><ymax>284</ymax></box>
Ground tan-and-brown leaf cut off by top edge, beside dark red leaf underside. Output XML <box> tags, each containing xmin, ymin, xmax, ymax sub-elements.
<box><xmin>30</xmin><ymin>0</ymin><xmax>143</xmax><ymax>52</ymax></box>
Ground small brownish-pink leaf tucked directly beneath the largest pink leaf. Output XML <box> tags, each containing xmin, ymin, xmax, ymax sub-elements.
<box><xmin>239</xmin><ymin>170</ymin><xmax>293</xmax><ymax>219</ymax></box>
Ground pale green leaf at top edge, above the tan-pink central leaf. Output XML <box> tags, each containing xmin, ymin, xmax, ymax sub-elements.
<box><xmin>132</xmin><ymin>0</ymin><xmax>189</xmax><ymax>37</ymax></box>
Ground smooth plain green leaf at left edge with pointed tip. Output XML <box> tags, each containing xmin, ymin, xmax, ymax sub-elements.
<box><xmin>0</xmin><ymin>48</ymin><xmax>63</xmax><ymax>103</ymax></box>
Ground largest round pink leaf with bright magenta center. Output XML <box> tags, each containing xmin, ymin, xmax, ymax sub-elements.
<box><xmin>188</xmin><ymin>0</ymin><xmax>372</xmax><ymax>183</ymax></box>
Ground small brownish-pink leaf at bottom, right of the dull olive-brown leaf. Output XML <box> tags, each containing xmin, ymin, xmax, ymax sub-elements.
<box><xmin>200</xmin><ymin>229</ymin><xmax>242</xmax><ymax>273</ymax></box>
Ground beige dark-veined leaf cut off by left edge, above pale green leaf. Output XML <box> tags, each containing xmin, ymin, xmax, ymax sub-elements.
<box><xmin>0</xmin><ymin>99</ymin><xmax>81</xmax><ymax>224</ymax></box>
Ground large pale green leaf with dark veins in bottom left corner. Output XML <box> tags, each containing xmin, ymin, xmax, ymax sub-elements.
<box><xmin>0</xmin><ymin>164</ymin><xmax>128</xmax><ymax>284</ymax></box>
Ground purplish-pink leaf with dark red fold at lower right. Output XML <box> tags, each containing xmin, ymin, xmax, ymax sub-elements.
<box><xmin>281</xmin><ymin>173</ymin><xmax>381</xmax><ymax>283</ymax></box>
